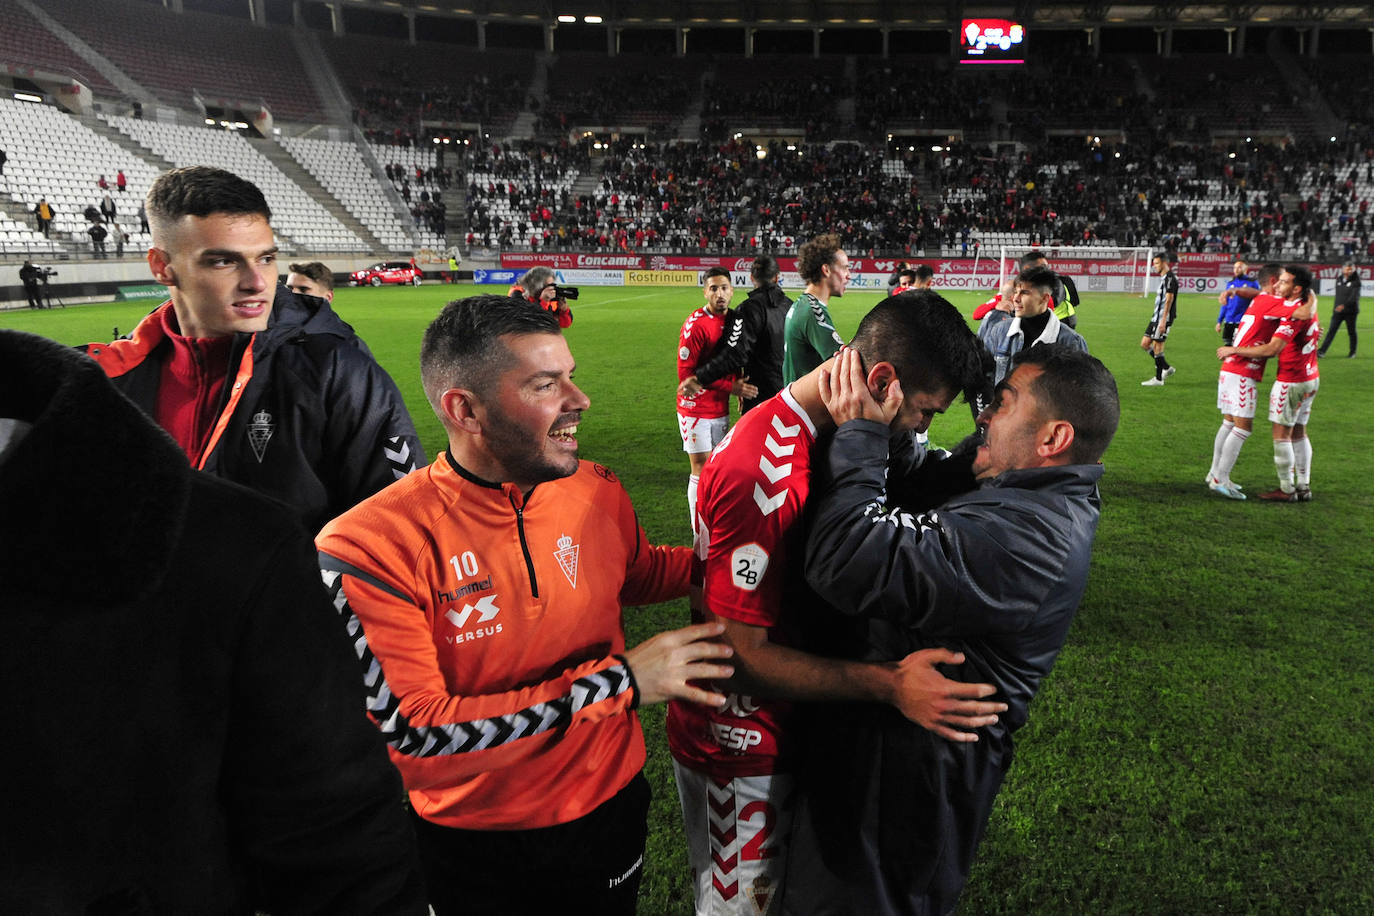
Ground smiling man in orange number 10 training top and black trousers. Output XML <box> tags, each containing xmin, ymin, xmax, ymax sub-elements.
<box><xmin>316</xmin><ymin>295</ymin><xmax>732</xmax><ymax>916</ymax></box>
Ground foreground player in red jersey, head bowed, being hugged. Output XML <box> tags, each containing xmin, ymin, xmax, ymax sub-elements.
<box><xmin>668</xmin><ymin>290</ymin><xmax>1004</xmax><ymax>915</ymax></box>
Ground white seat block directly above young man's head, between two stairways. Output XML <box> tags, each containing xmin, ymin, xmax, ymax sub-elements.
<box><xmin>104</xmin><ymin>117</ymin><xmax>368</xmax><ymax>251</ymax></box>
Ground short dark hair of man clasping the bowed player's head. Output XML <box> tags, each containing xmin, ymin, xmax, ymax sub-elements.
<box><xmin>1011</xmin><ymin>343</ymin><xmax>1121</xmax><ymax>464</ymax></box>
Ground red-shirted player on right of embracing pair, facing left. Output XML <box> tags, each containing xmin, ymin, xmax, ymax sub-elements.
<box><xmin>1238</xmin><ymin>265</ymin><xmax>1322</xmax><ymax>503</ymax></box>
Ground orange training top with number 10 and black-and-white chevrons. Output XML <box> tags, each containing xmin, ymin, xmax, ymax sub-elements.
<box><xmin>316</xmin><ymin>452</ymin><xmax>691</xmax><ymax>829</ymax></box>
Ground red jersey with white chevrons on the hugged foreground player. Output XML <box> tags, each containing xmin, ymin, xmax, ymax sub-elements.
<box><xmin>668</xmin><ymin>389</ymin><xmax>816</xmax><ymax>779</ymax></box>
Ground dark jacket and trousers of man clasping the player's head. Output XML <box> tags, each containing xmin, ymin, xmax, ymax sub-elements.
<box><xmin>785</xmin><ymin>420</ymin><xmax>1102</xmax><ymax>913</ymax></box>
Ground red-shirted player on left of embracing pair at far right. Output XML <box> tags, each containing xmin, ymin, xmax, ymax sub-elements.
<box><xmin>1206</xmin><ymin>264</ymin><xmax>1312</xmax><ymax>500</ymax></box>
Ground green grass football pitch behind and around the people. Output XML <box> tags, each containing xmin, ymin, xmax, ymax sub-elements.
<box><xmin>0</xmin><ymin>286</ymin><xmax>1374</xmax><ymax>916</ymax></box>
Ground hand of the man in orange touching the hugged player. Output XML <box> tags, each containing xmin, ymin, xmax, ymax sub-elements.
<box><xmin>625</xmin><ymin>621</ymin><xmax>735</xmax><ymax>709</ymax></box>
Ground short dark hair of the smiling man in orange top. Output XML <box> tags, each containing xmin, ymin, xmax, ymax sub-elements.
<box><xmin>420</xmin><ymin>295</ymin><xmax>559</xmax><ymax>411</ymax></box>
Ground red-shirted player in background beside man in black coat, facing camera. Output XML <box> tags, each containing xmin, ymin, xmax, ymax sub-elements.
<box><xmin>677</xmin><ymin>266</ymin><xmax>758</xmax><ymax>526</ymax></box>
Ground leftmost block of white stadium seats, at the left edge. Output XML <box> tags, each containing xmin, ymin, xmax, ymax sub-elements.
<box><xmin>0</xmin><ymin>99</ymin><xmax>158</xmax><ymax>254</ymax></box>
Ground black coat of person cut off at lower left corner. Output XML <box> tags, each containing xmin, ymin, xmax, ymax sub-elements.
<box><xmin>0</xmin><ymin>331</ymin><xmax>426</xmax><ymax>916</ymax></box>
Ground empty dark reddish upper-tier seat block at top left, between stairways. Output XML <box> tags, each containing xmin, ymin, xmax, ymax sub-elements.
<box><xmin>43</xmin><ymin>0</ymin><xmax>324</xmax><ymax>122</ymax></box>
